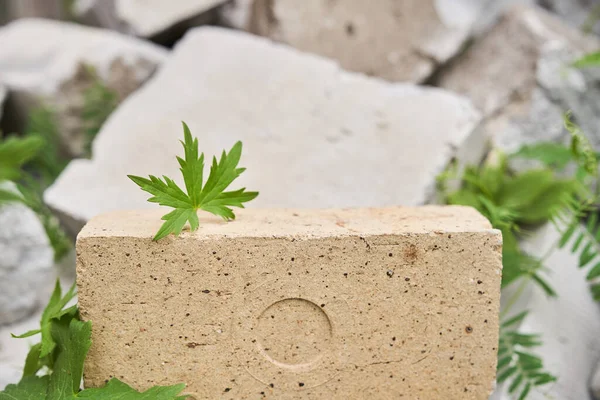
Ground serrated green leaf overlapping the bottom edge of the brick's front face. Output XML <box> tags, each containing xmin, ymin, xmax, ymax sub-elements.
<box><xmin>77</xmin><ymin>378</ymin><xmax>187</xmax><ymax>400</ymax></box>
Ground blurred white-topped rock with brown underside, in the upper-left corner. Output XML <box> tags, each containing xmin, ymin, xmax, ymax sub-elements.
<box><xmin>0</xmin><ymin>19</ymin><xmax>168</xmax><ymax>156</ymax></box>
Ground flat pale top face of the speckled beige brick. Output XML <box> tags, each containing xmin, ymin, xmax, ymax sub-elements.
<box><xmin>78</xmin><ymin>206</ymin><xmax>500</xmax><ymax>240</ymax></box>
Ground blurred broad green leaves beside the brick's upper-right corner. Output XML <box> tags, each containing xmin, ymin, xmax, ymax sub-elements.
<box><xmin>445</xmin><ymin>152</ymin><xmax>579</xmax><ymax>295</ymax></box>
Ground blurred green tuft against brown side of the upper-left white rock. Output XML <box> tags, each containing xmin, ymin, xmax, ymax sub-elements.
<box><xmin>81</xmin><ymin>78</ymin><xmax>119</xmax><ymax>156</ymax></box>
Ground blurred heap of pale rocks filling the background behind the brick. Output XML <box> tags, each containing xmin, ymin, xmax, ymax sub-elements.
<box><xmin>0</xmin><ymin>0</ymin><xmax>600</xmax><ymax>400</ymax></box>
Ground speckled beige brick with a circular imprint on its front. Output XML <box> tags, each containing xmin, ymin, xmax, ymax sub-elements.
<box><xmin>77</xmin><ymin>206</ymin><xmax>502</xmax><ymax>400</ymax></box>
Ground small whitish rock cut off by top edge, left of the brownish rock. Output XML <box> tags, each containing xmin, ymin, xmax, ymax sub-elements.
<box><xmin>116</xmin><ymin>0</ymin><xmax>227</xmax><ymax>38</ymax></box>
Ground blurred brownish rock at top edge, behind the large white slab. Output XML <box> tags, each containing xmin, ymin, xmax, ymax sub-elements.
<box><xmin>250</xmin><ymin>0</ymin><xmax>478</xmax><ymax>82</ymax></box>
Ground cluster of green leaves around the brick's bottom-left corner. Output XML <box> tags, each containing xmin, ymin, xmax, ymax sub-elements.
<box><xmin>0</xmin><ymin>282</ymin><xmax>187</xmax><ymax>400</ymax></box>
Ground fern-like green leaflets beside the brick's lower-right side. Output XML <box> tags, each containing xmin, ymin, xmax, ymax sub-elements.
<box><xmin>497</xmin><ymin>312</ymin><xmax>556</xmax><ymax>400</ymax></box>
